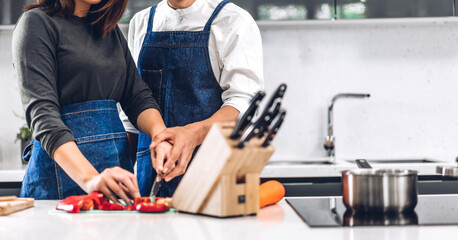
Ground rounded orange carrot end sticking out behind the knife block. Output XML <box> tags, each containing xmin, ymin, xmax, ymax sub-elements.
<box><xmin>259</xmin><ymin>180</ymin><xmax>285</xmax><ymax>208</ymax></box>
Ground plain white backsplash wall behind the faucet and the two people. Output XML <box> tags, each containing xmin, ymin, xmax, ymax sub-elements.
<box><xmin>0</xmin><ymin>18</ymin><xmax>458</xmax><ymax>166</ymax></box>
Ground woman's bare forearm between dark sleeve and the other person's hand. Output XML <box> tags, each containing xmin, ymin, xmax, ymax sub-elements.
<box><xmin>137</xmin><ymin>108</ymin><xmax>166</xmax><ymax>138</ymax></box>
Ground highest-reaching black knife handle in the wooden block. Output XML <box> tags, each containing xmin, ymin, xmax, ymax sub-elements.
<box><xmin>257</xmin><ymin>83</ymin><xmax>286</xmax><ymax>138</ymax></box>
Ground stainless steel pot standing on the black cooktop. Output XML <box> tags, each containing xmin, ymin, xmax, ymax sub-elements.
<box><xmin>342</xmin><ymin>160</ymin><xmax>418</xmax><ymax>213</ymax></box>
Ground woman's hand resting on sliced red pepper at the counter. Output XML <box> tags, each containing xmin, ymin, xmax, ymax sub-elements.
<box><xmin>83</xmin><ymin>167</ymin><xmax>140</xmax><ymax>205</ymax></box>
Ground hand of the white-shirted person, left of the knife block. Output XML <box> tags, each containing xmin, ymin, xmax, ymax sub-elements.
<box><xmin>150</xmin><ymin>123</ymin><xmax>206</xmax><ymax>182</ymax></box>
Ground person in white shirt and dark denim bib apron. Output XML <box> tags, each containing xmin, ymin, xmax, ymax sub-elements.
<box><xmin>121</xmin><ymin>0</ymin><xmax>264</xmax><ymax>196</ymax></box>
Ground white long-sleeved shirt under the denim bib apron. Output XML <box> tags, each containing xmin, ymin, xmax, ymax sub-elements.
<box><xmin>120</xmin><ymin>0</ymin><xmax>264</xmax><ymax>133</ymax></box>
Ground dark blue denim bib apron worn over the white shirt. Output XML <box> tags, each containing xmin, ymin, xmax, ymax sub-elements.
<box><xmin>137</xmin><ymin>0</ymin><xmax>229</xmax><ymax>197</ymax></box>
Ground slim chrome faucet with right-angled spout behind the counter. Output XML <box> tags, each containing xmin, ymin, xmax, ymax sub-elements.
<box><xmin>324</xmin><ymin>93</ymin><xmax>371</xmax><ymax>158</ymax></box>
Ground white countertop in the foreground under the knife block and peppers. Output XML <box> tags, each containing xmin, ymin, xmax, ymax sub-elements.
<box><xmin>0</xmin><ymin>200</ymin><xmax>458</xmax><ymax>240</ymax></box>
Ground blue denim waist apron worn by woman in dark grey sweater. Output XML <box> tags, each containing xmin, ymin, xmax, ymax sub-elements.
<box><xmin>21</xmin><ymin>100</ymin><xmax>133</xmax><ymax>199</ymax></box>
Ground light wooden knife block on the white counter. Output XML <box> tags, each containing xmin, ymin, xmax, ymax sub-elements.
<box><xmin>173</xmin><ymin>123</ymin><xmax>274</xmax><ymax>217</ymax></box>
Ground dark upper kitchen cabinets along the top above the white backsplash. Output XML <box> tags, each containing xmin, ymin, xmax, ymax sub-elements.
<box><xmin>4</xmin><ymin>0</ymin><xmax>456</xmax><ymax>25</ymax></box>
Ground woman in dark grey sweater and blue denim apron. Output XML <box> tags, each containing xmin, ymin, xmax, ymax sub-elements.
<box><xmin>13</xmin><ymin>0</ymin><xmax>171</xmax><ymax>204</ymax></box>
